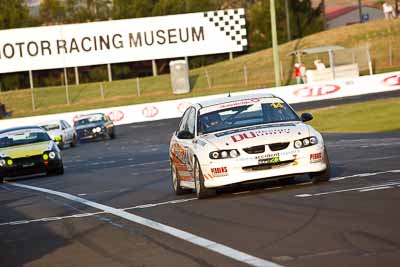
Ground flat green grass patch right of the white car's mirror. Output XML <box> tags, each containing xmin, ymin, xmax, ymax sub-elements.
<box><xmin>307</xmin><ymin>97</ymin><xmax>400</xmax><ymax>133</ymax></box>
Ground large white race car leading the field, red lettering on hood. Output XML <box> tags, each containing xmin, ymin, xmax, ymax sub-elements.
<box><xmin>169</xmin><ymin>94</ymin><xmax>330</xmax><ymax>198</ymax></box>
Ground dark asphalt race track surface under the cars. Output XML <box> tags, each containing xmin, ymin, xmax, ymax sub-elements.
<box><xmin>0</xmin><ymin>95</ymin><xmax>400</xmax><ymax>267</ymax></box>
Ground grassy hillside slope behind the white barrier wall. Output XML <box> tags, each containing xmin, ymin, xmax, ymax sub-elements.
<box><xmin>0</xmin><ymin>20</ymin><xmax>400</xmax><ymax>118</ymax></box>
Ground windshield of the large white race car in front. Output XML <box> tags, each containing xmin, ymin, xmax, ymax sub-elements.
<box><xmin>198</xmin><ymin>102</ymin><xmax>299</xmax><ymax>134</ymax></box>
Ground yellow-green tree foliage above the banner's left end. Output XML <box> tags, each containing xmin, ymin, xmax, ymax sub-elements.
<box><xmin>0</xmin><ymin>0</ymin><xmax>32</xmax><ymax>29</ymax></box>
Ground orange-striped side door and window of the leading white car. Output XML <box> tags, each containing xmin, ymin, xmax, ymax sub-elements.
<box><xmin>173</xmin><ymin>108</ymin><xmax>196</xmax><ymax>182</ymax></box>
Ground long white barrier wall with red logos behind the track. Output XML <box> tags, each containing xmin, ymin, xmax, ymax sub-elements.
<box><xmin>0</xmin><ymin>72</ymin><xmax>400</xmax><ymax>129</ymax></box>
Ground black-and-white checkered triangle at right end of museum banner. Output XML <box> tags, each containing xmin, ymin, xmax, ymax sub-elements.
<box><xmin>204</xmin><ymin>8</ymin><xmax>247</xmax><ymax>50</ymax></box>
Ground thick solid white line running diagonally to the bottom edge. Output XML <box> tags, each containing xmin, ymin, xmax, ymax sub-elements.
<box><xmin>6</xmin><ymin>183</ymin><xmax>280</xmax><ymax>267</ymax></box>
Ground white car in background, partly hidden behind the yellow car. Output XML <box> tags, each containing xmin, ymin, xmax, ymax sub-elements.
<box><xmin>39</xmin><ymin>120</ymin><xmax>78</xmax><ymax>149</ymax></box>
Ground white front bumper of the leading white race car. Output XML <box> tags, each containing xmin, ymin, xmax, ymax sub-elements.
<box><xmin>201</xmin><ymin>144</ymin><xmax>329</xmax><ymax>188</ymax></box>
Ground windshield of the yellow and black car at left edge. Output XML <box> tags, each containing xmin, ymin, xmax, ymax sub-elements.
<box><xmin>0</xmin><ymin>131</ymin><xmax>51</xmax><ymax>148</ymax></box>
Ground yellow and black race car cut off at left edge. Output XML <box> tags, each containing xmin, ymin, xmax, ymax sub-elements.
<box><xmin>0</xmin><ymin>126</ymin><xmax>64</xmax><ymax>183</ymax></box>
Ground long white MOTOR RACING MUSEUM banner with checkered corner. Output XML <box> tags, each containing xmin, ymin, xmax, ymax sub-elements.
<box><xmin>0</xmin><ymin>9</ymin><xmax>247</xmax><ymax>73</ymax></box>
